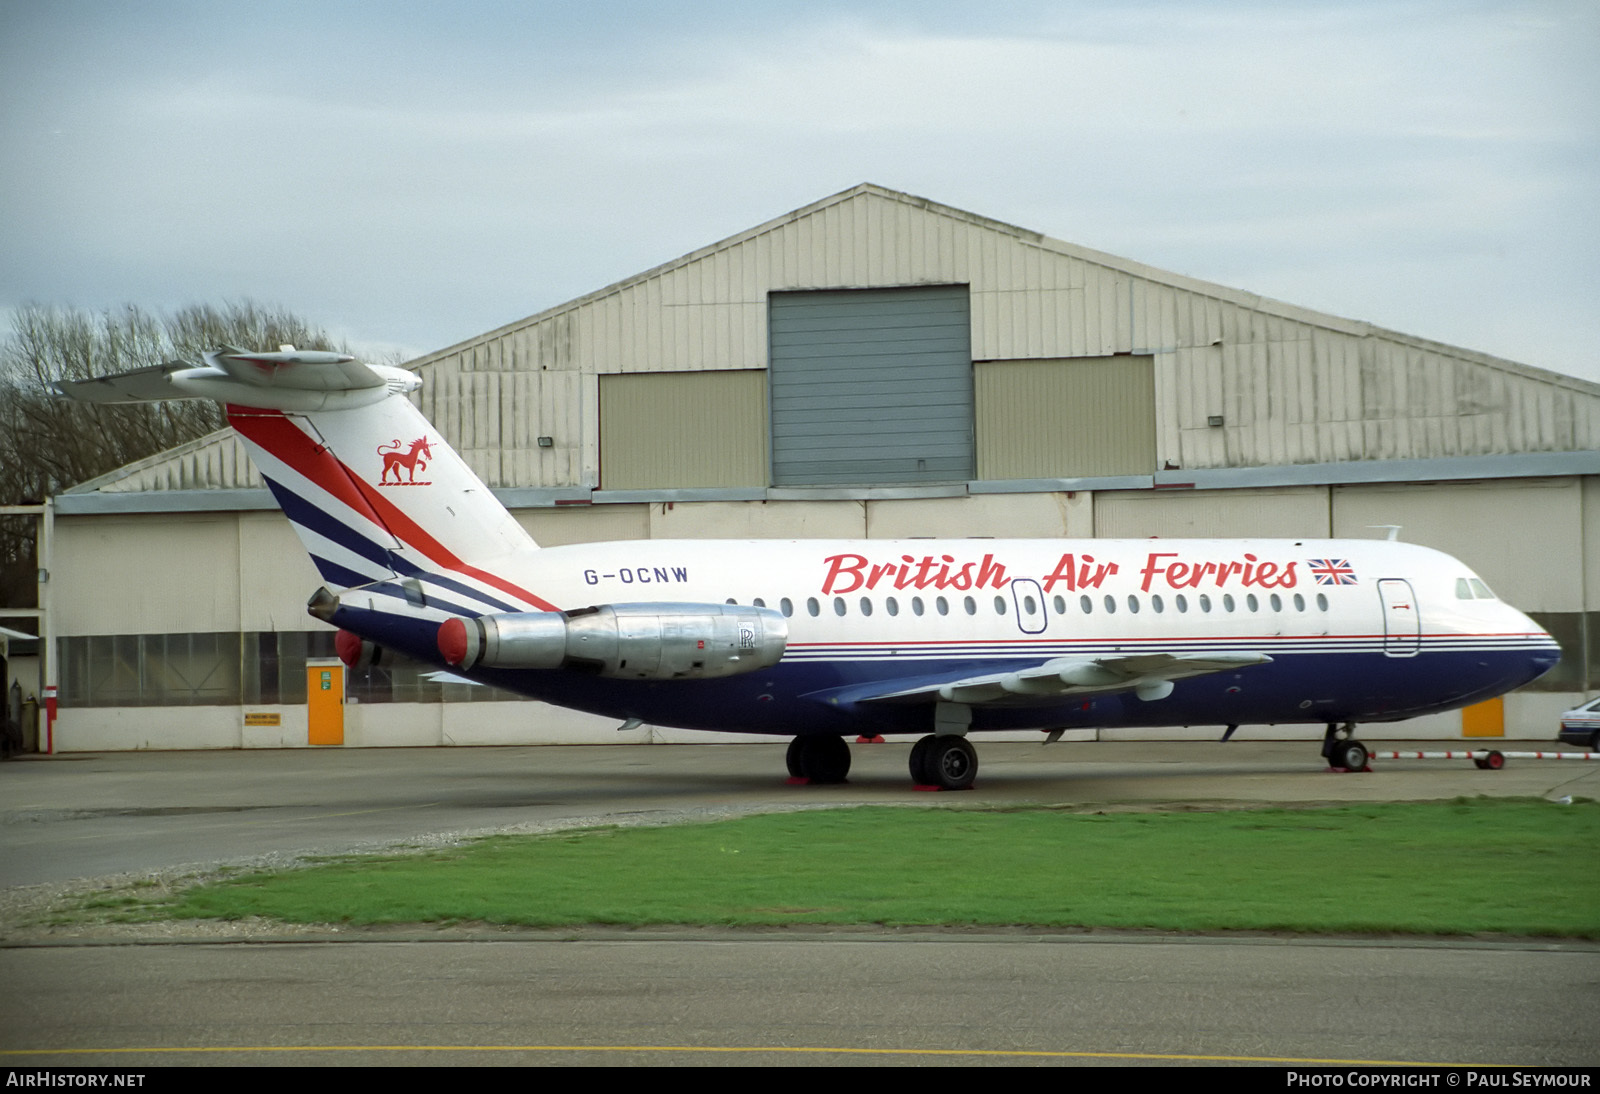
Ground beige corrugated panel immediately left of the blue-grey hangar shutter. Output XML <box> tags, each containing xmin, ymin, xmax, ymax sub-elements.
<box><xmin>600</xmin><ymin>369</ymin><xmax>766</xmax><ymax>489</ymax></box>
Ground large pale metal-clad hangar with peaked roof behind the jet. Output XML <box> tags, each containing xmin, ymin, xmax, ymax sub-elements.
<box><xmin>42</xmin><ymin>184</ymin><xmax>1600</xmax><ymax>750</ymax></box>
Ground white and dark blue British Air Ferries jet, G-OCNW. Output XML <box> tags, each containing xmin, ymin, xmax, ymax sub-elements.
<box><xmin>59</xmin><ymin>345</ymin><xmax>1560</xmax><ymax>789</ymax></box>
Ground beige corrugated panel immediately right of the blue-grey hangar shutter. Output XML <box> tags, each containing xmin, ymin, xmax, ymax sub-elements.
<box><xmin>973</xmin><ymin>357</ymin><xmax>1157</xmax><ymax>478</ymax></box>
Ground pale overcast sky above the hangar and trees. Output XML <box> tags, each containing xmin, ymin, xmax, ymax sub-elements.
<box><xmin>0</xmin><ymin>0</ymin><xmax>1600</xmax><ymax>381</ymax></box>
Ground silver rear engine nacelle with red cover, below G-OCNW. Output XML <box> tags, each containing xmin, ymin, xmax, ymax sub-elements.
<box><xmin>438</xmin><ymin>605</ymin><xmax>789</xmax><ymax>680</ymax></box>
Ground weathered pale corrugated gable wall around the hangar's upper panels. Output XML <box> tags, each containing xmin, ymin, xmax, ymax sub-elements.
<box><xmin>112</xmin><ymin>184</ymin><xmax>1600</xmax><ymax>486</ymax></box>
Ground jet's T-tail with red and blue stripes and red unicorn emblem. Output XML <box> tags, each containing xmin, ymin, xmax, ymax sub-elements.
<box><xmin>58</xmin><ymin>345</ymin><xmax>544</xmax><ymax>611</ymax></box>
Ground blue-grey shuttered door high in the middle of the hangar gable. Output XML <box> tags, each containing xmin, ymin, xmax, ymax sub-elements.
<box><xmin>768</xmin><ymin>285</ymin><xmax>976</xmax><ymax>486</ymax></box>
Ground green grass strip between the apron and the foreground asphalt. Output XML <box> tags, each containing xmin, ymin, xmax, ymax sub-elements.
<box><xmin>163</xmin><ymin>798</ymin><xmax>1600</xmax><ymax>939</ymax></box>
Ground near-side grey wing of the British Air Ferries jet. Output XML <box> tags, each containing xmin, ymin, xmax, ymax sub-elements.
<box><xmin>851</xmin><ymin>651</ymin><xmax>1272</xmax><ymax>707</ymax></box>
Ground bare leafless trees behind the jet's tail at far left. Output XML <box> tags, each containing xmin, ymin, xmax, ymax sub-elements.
<box><xmin>0</xmin><ymin>301</ymin><xmax>349</xmax><ymax>608</ymax></box>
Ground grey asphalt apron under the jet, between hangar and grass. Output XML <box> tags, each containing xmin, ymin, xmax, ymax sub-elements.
<box><xmin>0</xmin><ymin>739</ymin><xmax>1600</xmax><ymax>886</ymax></box>
